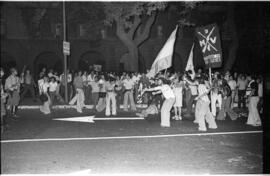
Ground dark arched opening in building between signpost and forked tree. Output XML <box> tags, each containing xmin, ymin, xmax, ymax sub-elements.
<box><xmin>78</xmin><ymin>51</ymin><xmax>106</xmax><ymax>71</ymax></box>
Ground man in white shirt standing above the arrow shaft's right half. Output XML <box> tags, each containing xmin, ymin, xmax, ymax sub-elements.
<box><xmin>123</xmin><ymin>74</ymin><xmax>136</xmax><ymax>111</ymax></box>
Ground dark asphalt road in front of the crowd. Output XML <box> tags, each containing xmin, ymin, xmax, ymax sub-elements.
<box><xmin>1</xmin><ymin>109</ymin><xmax>263</xmax><ymax>174</ymax></box>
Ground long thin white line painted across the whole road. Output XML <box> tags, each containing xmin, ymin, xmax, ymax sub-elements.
<box><xmin>1</xmin><ymin>131</ymin><xmax>263</xmax><ymax>144</ymax></box>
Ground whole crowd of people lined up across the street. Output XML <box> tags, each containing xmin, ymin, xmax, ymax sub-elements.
<box><xmin>1</xmin><ymin>68</ymin><xmax>263</xmax><ymax>131</ymax></box>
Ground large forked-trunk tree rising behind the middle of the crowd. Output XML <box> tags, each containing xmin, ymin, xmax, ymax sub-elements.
<box><xmin>104</xmin><ymin>2</ymin><xmax>196</xmax><ymax>71</ymax></box>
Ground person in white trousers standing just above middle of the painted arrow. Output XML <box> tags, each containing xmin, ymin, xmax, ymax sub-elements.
<box><xmin>105</xmin><ymin>77</ymin><xmax>116</xmax><ymax>116</ymax></box>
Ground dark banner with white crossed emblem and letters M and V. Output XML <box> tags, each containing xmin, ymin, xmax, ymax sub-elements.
<box><xmin>196</xmin><ymin>24</ymin><xmax>222</xmax><ymax>68</ymax></box>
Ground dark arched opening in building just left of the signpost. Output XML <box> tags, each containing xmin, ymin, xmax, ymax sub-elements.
<box><xmin>34</xmin><ymin>52</ymin><xmax>63</xmax><ymax>75</ymax></box>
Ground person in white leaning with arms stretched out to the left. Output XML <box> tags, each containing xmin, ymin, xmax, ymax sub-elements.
<box><xmin>145</xmin><ymin>78</ymin><xmax>175</xmax><ymax>127</ymax></box>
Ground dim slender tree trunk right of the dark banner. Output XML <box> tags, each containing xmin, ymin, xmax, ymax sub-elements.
<box><xmin>224</xmin><ymin>4</ymin><xmax>239</xmax><ymax>70</ymax></box>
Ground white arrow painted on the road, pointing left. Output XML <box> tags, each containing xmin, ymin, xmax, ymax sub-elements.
<box><xmin>53</xmin><ymin>116</ymin><xmax>144</xmax><ymax>123</ymax></box>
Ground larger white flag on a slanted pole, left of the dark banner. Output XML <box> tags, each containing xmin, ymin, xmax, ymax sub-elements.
<box><xmin>147</xmin><ymin>26</ymin><xmax>178</xmax><ymax>78</ymax></box>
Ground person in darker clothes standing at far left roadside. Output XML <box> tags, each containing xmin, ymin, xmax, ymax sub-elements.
<box><xmin>5</xmin><ymin>68</ymin><xmax>21</xmax><ymax>118</ymax></box>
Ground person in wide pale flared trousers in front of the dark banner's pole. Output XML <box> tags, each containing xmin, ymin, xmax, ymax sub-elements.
<box><xmin>195</xmin><ymin>76</ymin><xmax>217</xmax><ymax>131</ymax></box>
